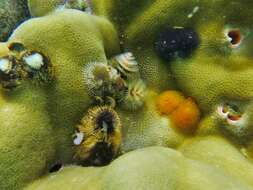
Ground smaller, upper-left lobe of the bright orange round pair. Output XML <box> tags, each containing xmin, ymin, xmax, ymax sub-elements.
<box><xmin>156</xmin><ymin>90</ymin><xmax>185</xmax><ymax>115</ymax></box>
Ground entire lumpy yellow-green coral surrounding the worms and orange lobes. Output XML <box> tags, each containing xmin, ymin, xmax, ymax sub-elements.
<box><xmin>0</xmin><ymin>0</ymin><xmax>253</xmax><ymax>190</ymax></box>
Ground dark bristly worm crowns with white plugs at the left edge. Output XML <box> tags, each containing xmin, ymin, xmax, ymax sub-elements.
<box><xmin>0</xmin><ymin>44</ymin><xmax>52</xmax><ymax>89</ymax></box>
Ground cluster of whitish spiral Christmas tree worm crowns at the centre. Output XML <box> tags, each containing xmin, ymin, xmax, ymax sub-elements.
<box><xmin>83</xmin><ymin>52</ymin><xmax>146</xmax><ymax>111</ymax></box>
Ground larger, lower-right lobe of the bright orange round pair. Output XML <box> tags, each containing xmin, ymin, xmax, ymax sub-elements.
<box><xmin>170</xmin><ymin>98</ymin><xmax>200</xmax><ymax>131</ymax></box>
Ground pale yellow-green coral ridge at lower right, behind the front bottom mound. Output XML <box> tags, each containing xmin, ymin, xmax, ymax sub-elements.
<box><xmin>179</xmin><ymin>136</ymin><xmax>253</xmax><ymax>187</ymax></box>
